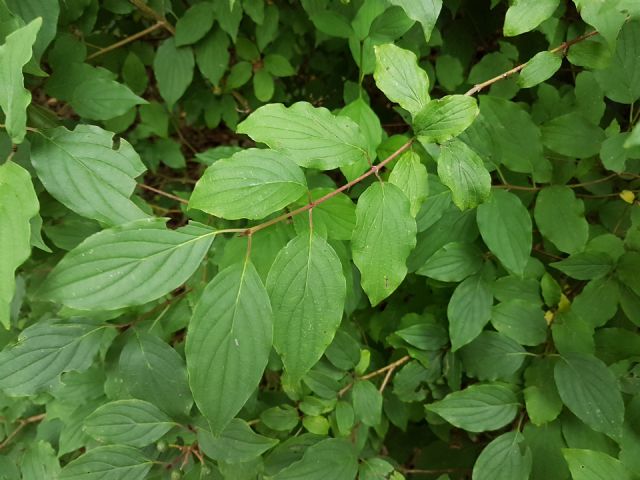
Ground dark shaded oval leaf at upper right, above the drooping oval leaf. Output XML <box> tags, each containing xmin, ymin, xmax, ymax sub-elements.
<box><xmin>542</xmin><ymin>113</ymin><xmax>605</xmax><ymax>158</ymax></box>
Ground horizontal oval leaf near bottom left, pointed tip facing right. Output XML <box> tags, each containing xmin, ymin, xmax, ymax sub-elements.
<box><xmin>84</xmin><ymin>399</ymin><xmax>175</xmax><ymax>447</ymax></box>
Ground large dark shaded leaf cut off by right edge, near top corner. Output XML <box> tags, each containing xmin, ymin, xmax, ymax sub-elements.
<box><xmin>593</xmin><ymin>20</ymin><xmax>640</xmax><ymax>104</ymax></box>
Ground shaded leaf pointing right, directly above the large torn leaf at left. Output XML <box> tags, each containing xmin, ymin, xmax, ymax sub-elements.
<box><xmin>70</xmin><ymin>78</ymin><xmax>147</xmax><ymax>120</ymax></box>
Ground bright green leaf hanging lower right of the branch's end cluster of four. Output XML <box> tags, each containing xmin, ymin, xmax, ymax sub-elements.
<box><xmin>438</xmin><ymin>140</ymin><xmax>491</xmax><ymax>210</ymax></box>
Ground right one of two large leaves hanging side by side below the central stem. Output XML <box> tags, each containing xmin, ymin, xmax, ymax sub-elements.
<box><xmin>267</xmin><ymin>232</ymin><xmax>346</xmax><ymax>382</ymax></box>
